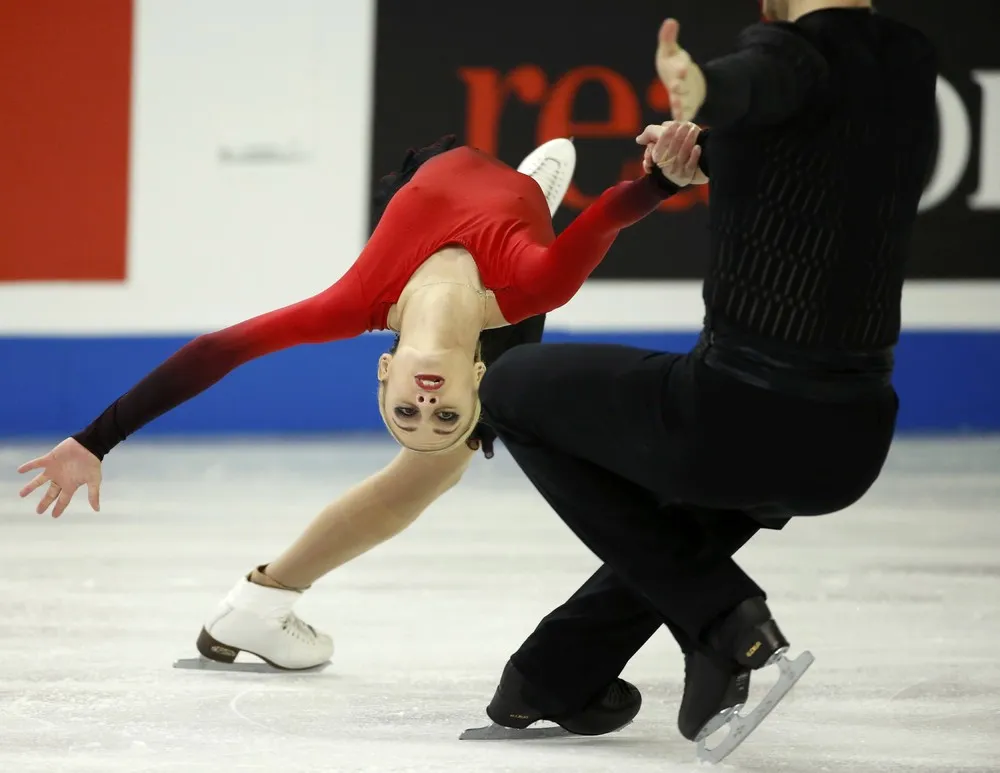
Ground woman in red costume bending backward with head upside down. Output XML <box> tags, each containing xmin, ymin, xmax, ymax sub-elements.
<box><xmin>13</xmin><ymin>123</ymin><xmax>701</xmax><ymax>670</ymax></box>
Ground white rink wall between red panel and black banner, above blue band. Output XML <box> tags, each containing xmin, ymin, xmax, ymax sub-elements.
<box><xmin>0</xmin><ymin>0</ymin><xmax>1000</xmax><ymax>335</ymax></box>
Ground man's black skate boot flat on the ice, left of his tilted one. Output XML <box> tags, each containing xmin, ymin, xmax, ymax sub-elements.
<box><xmin>474</xmin><ymin>662</ymin><xmax>642</xmax><ymax>737</ymax></box>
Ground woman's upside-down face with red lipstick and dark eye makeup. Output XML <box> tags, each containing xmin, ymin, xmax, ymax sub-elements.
<box><xmin>378</xmin><ymin>347</ymin><xmax>486</xmax><ymax>451</ymax></box>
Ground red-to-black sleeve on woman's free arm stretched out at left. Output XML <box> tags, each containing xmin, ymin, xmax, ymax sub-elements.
<box><xmin>73</xmin><ymin>268</ymin><xmax>369</xmax><ymax>459</ymax></box>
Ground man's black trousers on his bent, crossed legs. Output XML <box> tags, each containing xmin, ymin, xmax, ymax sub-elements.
<box><xmin>480</xmin><ymin>344</ymin><xmax>897</xmax><ymax>703</ymax></box>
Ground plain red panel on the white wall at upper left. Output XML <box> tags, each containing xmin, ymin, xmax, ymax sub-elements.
<box><xmin>0</xmin><ymin>0</ymin><xmax>133</xmax><ymax>282</ymax></box>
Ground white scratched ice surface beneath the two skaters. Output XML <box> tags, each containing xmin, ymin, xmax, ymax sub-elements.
<box><xmin>0</xmin><ymin>439</ymin><xmax>1000</xmax><ymax>773</ymax></box>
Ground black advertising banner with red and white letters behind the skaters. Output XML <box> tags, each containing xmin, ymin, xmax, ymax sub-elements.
<box><xmin>372</xmin><ymin>0</ymin><xmax>1000</xmax><ymax>279</ymax></box>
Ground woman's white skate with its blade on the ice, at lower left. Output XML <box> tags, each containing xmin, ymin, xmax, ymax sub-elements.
<box><xmin>174</xmin><ymin>577</ymin><xmax>333</xmax><ymax>671</ymax></box>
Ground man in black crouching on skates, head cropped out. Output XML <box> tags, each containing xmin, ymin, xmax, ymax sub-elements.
<box><xmin>464</xmin><ymin>0</ymin><xmax>937</xmax><ymax>761</ymax></box>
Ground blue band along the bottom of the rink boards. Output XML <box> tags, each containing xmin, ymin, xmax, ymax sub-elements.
<box><xmin>0</xmin><ymin>331</ymin><xmax>1000</xmax><ymax>437</ymax></box>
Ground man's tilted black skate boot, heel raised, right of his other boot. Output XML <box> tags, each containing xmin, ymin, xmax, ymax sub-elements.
<box><xmin>677</xmin><ymin>597</ymin><xmax>788</xmax><ymax>741</ymax></box>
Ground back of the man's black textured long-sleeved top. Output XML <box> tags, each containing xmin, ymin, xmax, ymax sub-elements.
<box><xmin>705</xmin><ymin>9</ymin><xmax>937</xmax><ymax>351</ymax></box>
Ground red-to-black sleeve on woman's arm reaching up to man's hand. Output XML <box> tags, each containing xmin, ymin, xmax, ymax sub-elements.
<box><xmin>501</xmin><ymin>169</ymin><xmax>680</xmax><ymax>323</ymax></box>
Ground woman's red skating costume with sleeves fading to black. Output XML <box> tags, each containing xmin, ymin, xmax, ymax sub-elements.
<box><xmin>74</xmin><ymin>147</ymin><xmax>678</xmax><ymax>459</ymax></box>
